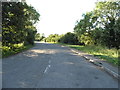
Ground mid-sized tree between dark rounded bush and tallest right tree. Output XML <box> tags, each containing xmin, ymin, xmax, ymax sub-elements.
<box><xmin>74</xmin><ymin>11</ymin><xmax>97</xmax><ymax>45</ymax></box>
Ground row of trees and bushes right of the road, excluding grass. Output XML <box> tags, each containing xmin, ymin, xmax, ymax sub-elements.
<box><xmin>46</xmin><ymin>1</ymin><xmax>120</xmax><ymax>49</ymax></box>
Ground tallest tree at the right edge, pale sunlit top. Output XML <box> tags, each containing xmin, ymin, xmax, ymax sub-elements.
<box><xmin>95</xmin><ymin>1</ymin><xmax>120</xmax><ymax>49</ymax></box>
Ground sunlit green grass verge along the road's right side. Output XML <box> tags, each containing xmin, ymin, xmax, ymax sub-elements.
<box><xmin>54</xmin><ymin>43</ymin><xmax>120</xmax><ymax>66</ymax></box>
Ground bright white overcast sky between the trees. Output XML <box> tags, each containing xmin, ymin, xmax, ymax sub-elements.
<box><xmin>26</xmin><ymin>0</ymin><xmax>97</xmax><ymax>36</ymax></box>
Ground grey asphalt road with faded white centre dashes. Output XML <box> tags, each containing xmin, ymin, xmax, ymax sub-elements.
<box><xmin>2</xmin><ymin>43</ymin><xmax>118</xmax><ymax>88</ymax></box>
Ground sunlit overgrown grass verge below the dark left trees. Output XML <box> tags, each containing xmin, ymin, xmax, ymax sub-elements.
<box><xmin>2</xmin><ymin>43</ymin><xmax>33</xmax><ymax>58</ymax></box>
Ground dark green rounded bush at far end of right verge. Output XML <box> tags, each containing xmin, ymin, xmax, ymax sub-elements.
<box><xmin>59</xmin><ymin>32</ymin><xmax>78</xmax><ymax>44</ymax></box>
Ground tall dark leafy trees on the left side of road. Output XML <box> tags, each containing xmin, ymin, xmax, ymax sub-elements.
<box><xmin>2</xmin><ymin>2</ymin><xmax>40</xmax><ymax>55</ymax></box>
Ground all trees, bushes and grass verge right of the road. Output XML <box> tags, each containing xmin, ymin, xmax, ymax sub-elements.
<box><xmin>45</xmin><ymin>1</ymin><xmax>120</xmax><ymax>66</ymax></box>
